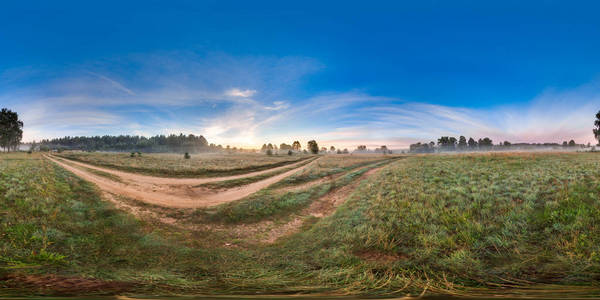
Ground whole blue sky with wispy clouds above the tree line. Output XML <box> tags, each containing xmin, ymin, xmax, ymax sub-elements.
<box><xmin>0</xmin><ymin>0</ymin><xmax>600</xmax><ymax>149</ymax></box>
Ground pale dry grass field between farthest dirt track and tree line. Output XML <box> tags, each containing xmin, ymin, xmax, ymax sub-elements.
<box><xmin>55</xmin><ymin>152</ymin><xmax>314</xmax><ymax>177</ymax></box>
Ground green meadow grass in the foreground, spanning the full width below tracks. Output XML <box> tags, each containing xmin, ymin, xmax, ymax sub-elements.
<box><xmin>0</xmin><ymin>153</ymin><xmax>600</xmax><ymax>296</ymax></box>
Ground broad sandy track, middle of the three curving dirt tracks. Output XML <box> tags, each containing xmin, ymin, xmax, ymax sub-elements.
<box><xmin>45</xmin><ymin>156</ymin><xmax>316</xmax><ymax>208</ymax></box>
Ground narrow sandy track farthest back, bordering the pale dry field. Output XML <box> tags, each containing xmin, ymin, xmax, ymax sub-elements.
<box><xmin>46</xmin><ymin>156</ymin><xmax>311</xmax><ymax>185</ymax></box>
